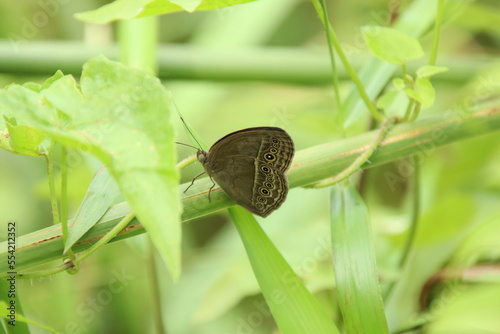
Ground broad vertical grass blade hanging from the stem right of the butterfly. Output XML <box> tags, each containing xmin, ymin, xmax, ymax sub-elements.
<box><xmin>330</xmin><ymin>184</ymin><xmax>389</xmax><ymax>334</ymax></box>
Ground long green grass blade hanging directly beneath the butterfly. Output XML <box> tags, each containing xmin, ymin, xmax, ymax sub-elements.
<box><xmin>229</xmin><ymin>206</ymin><xmax>338</xmax><ymax>334</ymax></box>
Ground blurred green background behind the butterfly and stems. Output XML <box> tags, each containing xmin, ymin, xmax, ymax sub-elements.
<box><xmin>0</xmin><ymin>0</ymin><xmax>500</xmax><ymax>334</ymax></box>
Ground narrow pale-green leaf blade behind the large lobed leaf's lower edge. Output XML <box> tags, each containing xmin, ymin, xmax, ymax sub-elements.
<box><xmin>64</xmin><ymin>167</ymin><xmax>120</xmax><ymax>253</ymax></box>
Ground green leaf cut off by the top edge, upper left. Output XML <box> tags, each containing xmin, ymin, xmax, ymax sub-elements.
<box><xmin>75</xmin><ymin>0</ymin><xmax>254</xmax><ymax>23</ymax></box>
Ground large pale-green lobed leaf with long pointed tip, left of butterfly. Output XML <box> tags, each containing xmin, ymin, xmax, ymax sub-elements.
<box><xmin>0</xmin><ymin>56</ymin><xmax>181</xmax><ymax>279</ymax></box>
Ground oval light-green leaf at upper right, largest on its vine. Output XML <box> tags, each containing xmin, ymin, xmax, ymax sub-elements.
<box><xmin>362</xmin><ymin>26</ymin><xmax>424</xmax><ymax>65</ymax></box>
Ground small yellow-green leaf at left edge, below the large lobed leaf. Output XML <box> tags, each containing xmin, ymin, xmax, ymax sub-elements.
<box><xmin>4</xmin><ymin>116</ymin><xmax>45</xmax><ymax>157</ymax></box>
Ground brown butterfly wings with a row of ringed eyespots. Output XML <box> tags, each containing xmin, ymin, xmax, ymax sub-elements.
<box><xmin>204</xmin><ymin>127</ymin><xmax>294</xmax><ymax>217</ymax></box>
